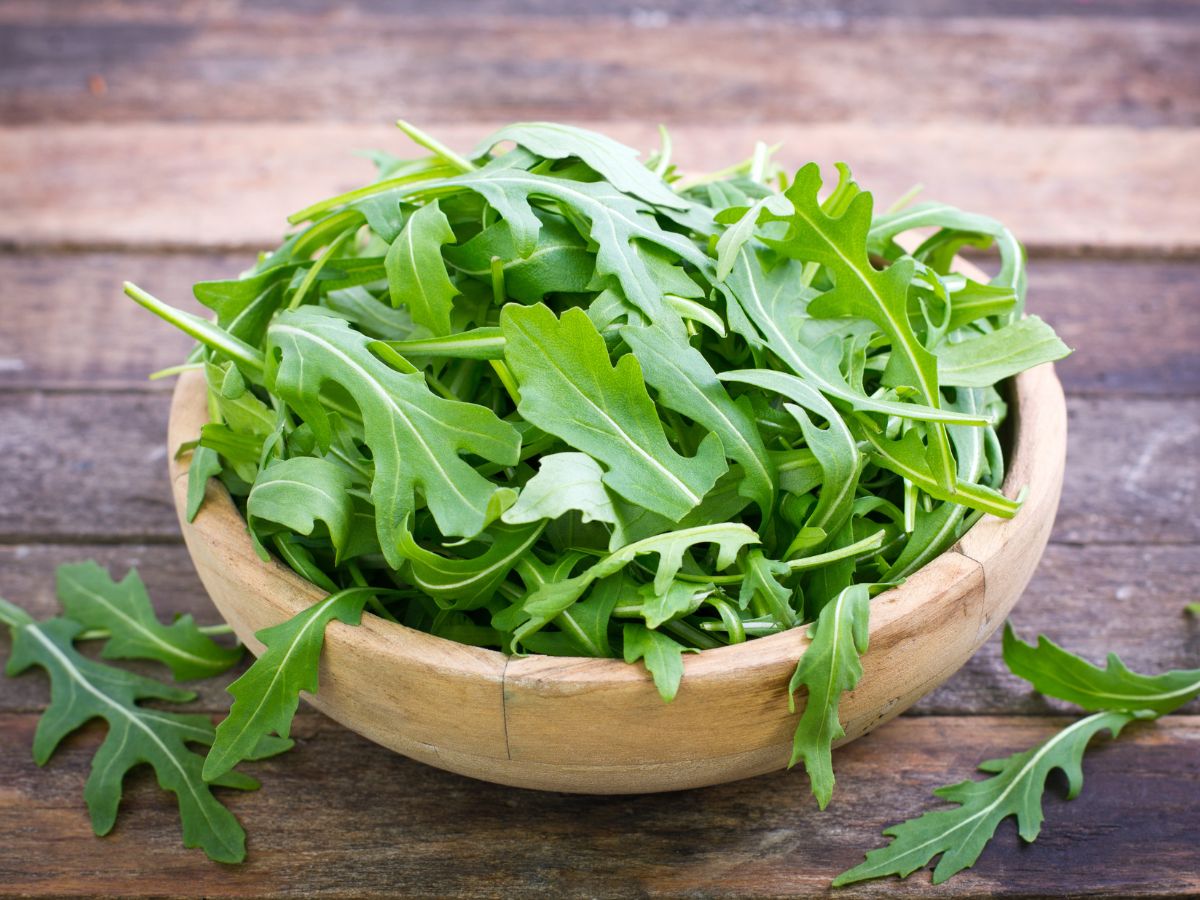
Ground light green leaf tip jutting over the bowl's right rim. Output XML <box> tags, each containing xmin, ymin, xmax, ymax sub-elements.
<box><xmin>937</xmin><ymin>316</ymin><xmax>1070</xmax><ymax>388</ymax></box>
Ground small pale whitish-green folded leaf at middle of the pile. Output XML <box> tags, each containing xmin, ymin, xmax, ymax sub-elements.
<box><xmin>502</xmin><ymin>452</ymin><xmax>617</xmax><ymax>524</ymax></box>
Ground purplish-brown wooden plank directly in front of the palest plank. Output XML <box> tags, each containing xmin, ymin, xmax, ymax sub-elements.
<box><xmin>0</xmin><ymin>251</ymin><xmax>1200</xmax><ymax>396</ymax></box>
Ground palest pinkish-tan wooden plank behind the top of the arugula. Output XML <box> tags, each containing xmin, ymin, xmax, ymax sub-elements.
<box><xmin>0</xmin><ymin>124</ymin><xmax>1200</xmax><ymax>253</ymax></box>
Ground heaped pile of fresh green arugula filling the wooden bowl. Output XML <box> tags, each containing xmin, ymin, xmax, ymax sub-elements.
<box><xmin>126</xmin><ymin>124</ymin><xmax>1068</xmax><ymax>806</ymax></box>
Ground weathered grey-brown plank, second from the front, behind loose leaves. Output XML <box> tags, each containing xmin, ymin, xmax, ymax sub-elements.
<box><xmin>0</xmin><ymin>544</ymin><xmax>1200</xmax><ymax>715</ymax></box>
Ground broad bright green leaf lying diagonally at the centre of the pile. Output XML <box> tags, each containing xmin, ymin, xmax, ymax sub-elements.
<box><xmin>500</xmin><ymin>304</ymin><xmax>727</xmax><ymax>520</ymax></box>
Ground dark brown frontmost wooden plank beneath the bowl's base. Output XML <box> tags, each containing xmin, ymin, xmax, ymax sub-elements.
<box><xmin>0</xmin><ymin>715</ymin><xmax>1200</xmax><ymax>898</ymax></box>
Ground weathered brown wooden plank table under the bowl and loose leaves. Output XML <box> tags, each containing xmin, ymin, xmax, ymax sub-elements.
<box><xmin>0</xmin><ymin>0</ymin><xmax>1200</xmax><ymax>898</ymax></box>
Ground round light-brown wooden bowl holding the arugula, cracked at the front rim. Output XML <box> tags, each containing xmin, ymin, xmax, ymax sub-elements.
<box><xmin>168</xmin><ymin>365</ymin><xmax>1067</xmax><ymax>793</ymax></box>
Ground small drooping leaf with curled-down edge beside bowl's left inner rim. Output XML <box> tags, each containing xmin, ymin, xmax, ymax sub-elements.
<box><xmin>246</xmin><ymin>456</ymin><xmax>354</xmax><ymax>560</ymax></box>
